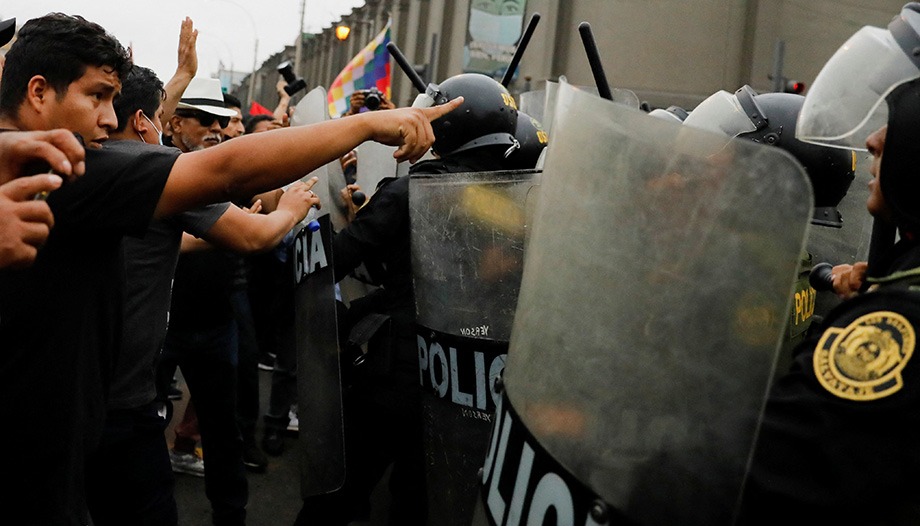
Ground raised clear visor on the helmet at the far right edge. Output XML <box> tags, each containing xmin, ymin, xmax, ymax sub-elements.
<box><xmin>796</xmin><ymin>26</ymin><xmax>920</xmax><ymax>150</ymax></box>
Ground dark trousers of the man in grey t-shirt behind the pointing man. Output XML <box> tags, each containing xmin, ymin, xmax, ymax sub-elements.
<box><xmin>86</xmin><ymin>402</ymin><xmax>179</xmax><ymax>526</ymax></box>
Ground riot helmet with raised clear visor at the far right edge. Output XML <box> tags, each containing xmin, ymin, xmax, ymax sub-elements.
<box><xmin>796</xmin><ymin>2</ymin><xmax>920</xmax><ymax>231</ymax></box>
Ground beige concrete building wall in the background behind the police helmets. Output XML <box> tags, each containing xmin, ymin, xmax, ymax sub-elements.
<box><xmin>237</xmin><ymin>0</ymin><xmax>904</xmax><ymax>115</ymax></box>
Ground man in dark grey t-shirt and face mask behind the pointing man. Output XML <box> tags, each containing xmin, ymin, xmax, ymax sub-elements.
<box><xmin>88</xmin><ymin>66</ymin><xmax>320</xmax><ymax>526</ymax></box>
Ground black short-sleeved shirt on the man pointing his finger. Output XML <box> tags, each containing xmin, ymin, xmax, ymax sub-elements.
<box><xmin>0</xmin><ymin>139</ymin><xmax>179</xmax><ymax>524</ymax></box>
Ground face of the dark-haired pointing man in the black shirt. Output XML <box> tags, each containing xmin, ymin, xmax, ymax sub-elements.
<box><xmin>41</xmin><ymin>66</ymin><xmax>121</xmax><ymax>147</ymax></box>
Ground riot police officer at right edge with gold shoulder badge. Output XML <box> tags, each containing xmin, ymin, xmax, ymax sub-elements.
<box><xmin>742</xmin><ymin>3</ymin><xmax>920</xmax><ymax>524</ymax></box>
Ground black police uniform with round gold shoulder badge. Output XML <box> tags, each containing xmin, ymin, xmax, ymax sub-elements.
<box><xmin>741</xmin><ymin>239</ymin><xmax>920</xmax><ymax>524</ymax></box>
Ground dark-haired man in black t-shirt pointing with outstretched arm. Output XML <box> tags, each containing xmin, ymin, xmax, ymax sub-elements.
<box><xmin>0</xmin><ymin>14</ymin><xmax>459</xmax><ymax>525</ymax></box>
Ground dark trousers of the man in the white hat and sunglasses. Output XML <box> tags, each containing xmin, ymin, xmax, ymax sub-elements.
<box><xmin>158</xmin><ymin>321</ymin><xmax>249</xmax><ymax>525</ymax></box>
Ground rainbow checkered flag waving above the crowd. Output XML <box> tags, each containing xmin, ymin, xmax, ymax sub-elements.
<box><xmin>329</xmin><ymin>21</ymin><xmax>390</xmax><ymax>117</ymax></box>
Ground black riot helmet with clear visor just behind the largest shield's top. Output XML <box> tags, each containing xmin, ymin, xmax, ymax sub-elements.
<box><xmin>684</xmin><ymin>85</ymin><xmax>856</xmax><ymax>228</ymax></box>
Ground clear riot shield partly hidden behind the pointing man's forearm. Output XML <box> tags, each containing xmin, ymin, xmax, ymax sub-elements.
<box><xmin>291</xmin><ymin>86</ymin><xmax>347</xmax><ymax>230</ymax></box>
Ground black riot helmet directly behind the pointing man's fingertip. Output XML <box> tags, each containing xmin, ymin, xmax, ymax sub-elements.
<box><xmin>431</xmin><ymin>73</ymin><xmax>520</xmax><ymax>157</ymax></box>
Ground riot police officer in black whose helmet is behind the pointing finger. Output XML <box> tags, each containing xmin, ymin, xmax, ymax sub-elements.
<box><xmin>296</xmin><ymin>74</ymin><xmax>519</xmax><ymax>526</ymax></box>
